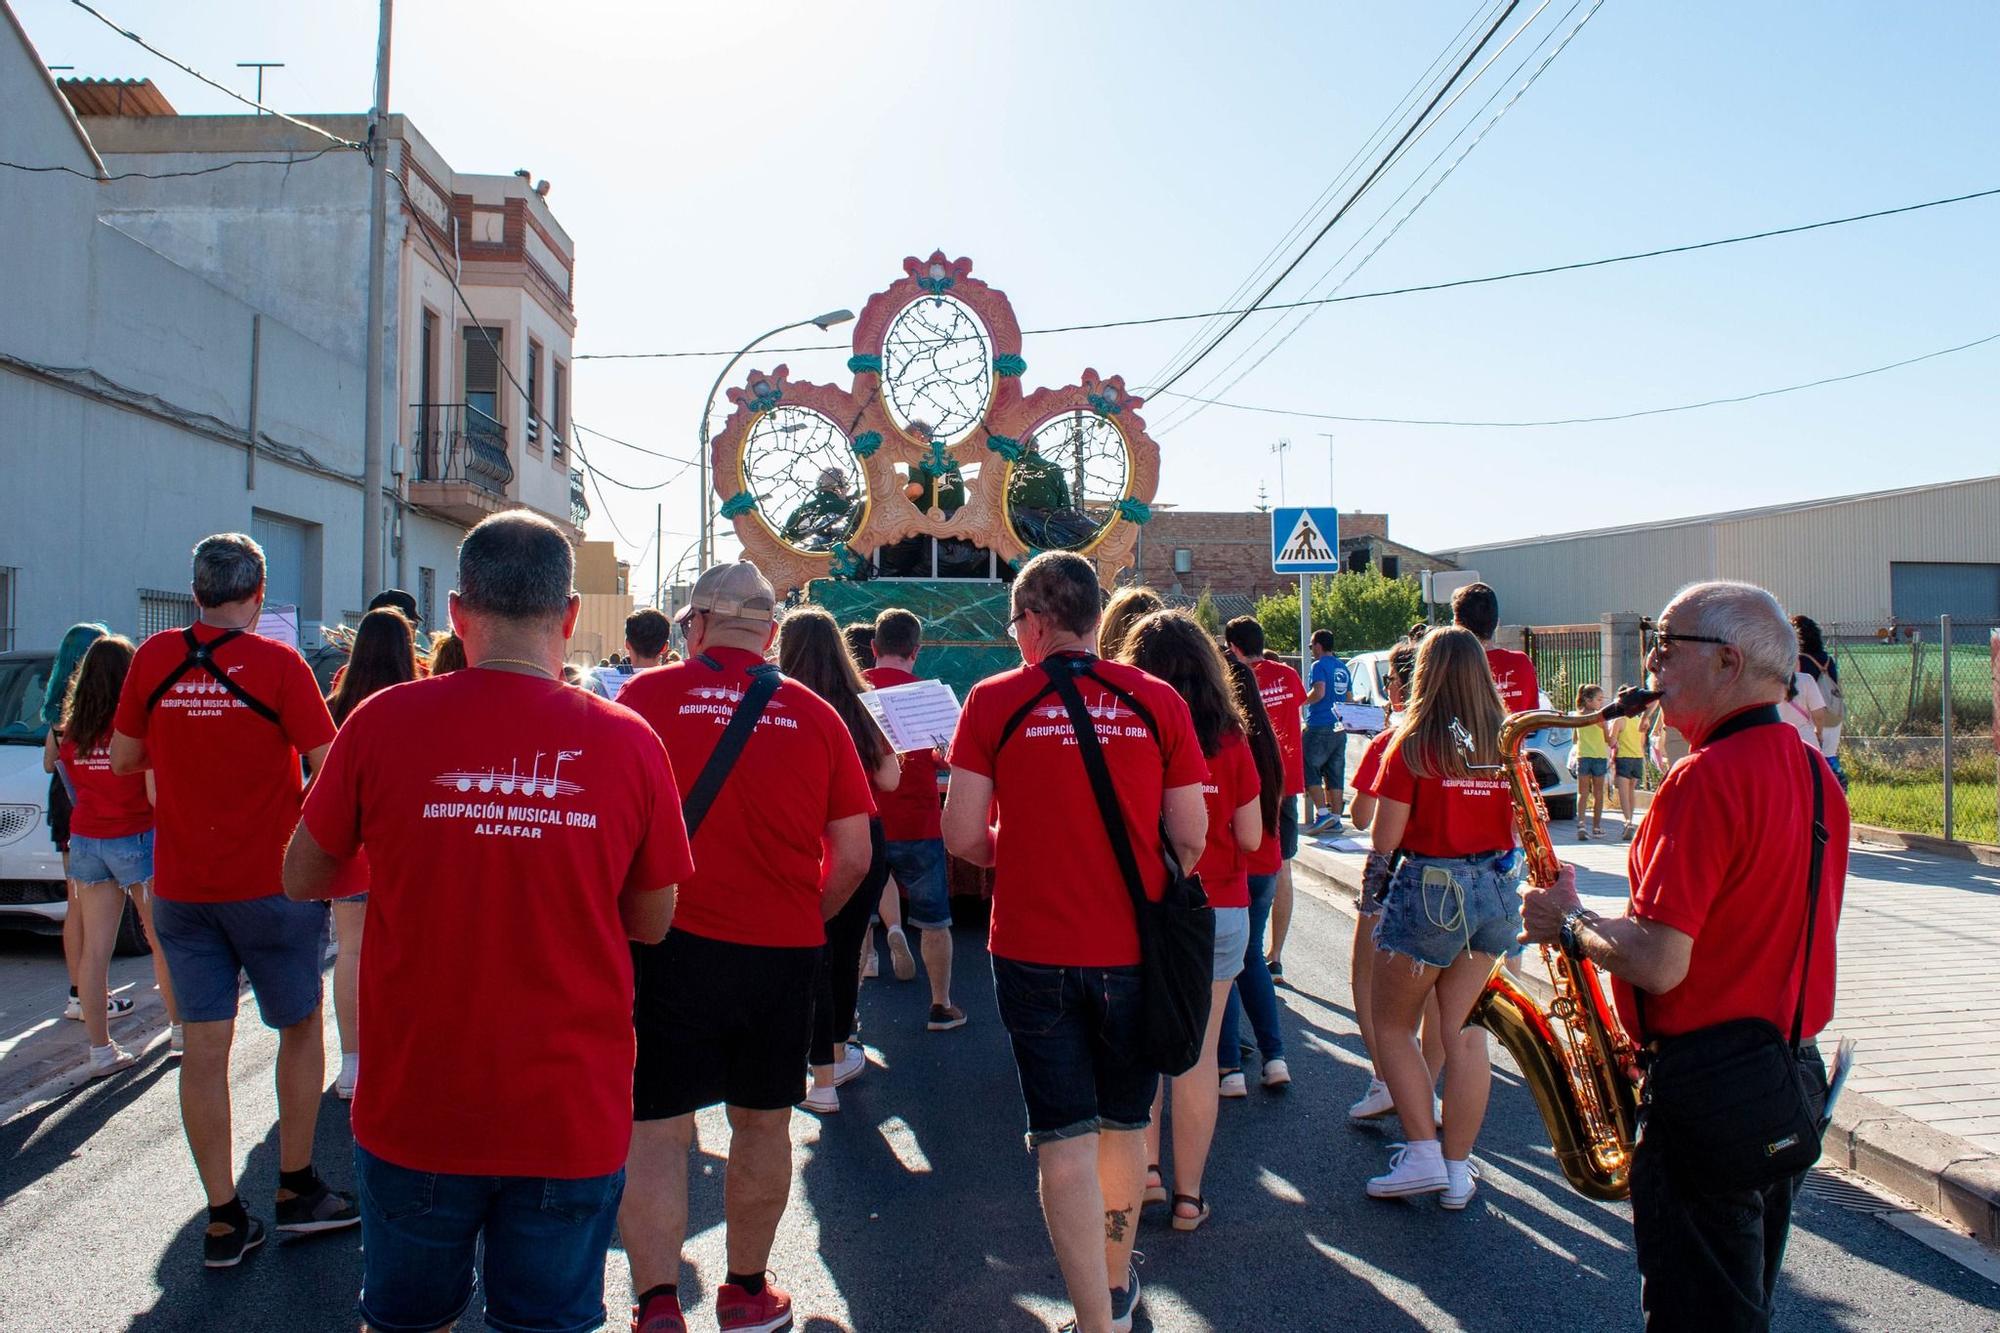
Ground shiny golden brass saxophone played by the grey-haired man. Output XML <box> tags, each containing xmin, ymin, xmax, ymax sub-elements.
<box><xmin>1466</xmin><ymin>689</ymin><xmax>1658</xmax><ymax>1199</ymax></box>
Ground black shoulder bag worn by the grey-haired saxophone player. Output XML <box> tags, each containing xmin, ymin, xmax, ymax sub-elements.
<box><xmin>1634</xmin><ymin>747</ymin><xmax>1826</xmax><ymax>1195</ymax></box>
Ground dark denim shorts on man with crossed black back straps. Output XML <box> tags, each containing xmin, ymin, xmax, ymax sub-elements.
<box><xmin>152</xmin><ymin>893</ymin><xmax>326</xmax><ymax>1029</ymax></box>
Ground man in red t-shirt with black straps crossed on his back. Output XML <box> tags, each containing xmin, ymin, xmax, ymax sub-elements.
<box><xmin>112</xmin><ymin>532</ymin><xmax>360</xmax><ymax>1269</ymax></box>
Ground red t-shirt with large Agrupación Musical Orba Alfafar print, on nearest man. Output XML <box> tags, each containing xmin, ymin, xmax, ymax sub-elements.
<box><xmin>306</xmin><ymin>669</ymin><xmax>690</xmax><ymax>1179</ymax></box>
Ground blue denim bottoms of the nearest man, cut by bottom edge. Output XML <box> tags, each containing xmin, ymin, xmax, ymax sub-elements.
<box><xmin>354</xmin><ymin>1143</ymin><xmax>624</xmax><ymax>1333</ymax></box>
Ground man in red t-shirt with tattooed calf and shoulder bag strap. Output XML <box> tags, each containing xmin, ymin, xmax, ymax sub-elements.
<box><xmin>944</xmin><ymin>550</ymin><xmax>1208</xmax><ymax>1329</ymax></box>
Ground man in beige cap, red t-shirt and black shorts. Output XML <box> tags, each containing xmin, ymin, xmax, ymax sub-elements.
<box><xmin>618</xmin><ymin>564</ymin><xmax>874</xmax><ymax>1329</ymax></box>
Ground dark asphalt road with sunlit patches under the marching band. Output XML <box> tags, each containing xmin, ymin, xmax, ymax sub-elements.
<box><xmin>0</xmin><ymin>872</ymin><xmax>2000</xmax><ymax>1333</ymax></box>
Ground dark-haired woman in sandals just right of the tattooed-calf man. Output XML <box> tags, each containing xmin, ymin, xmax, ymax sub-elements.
<box><xmin>1120</xmin><ymin>610</ymin><xmax>1276</xmax><ymax>1231</ymax></box>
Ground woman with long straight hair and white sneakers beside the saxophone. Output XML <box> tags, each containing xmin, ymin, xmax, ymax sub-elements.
<box><xmin>1364</xmin><ymin>628</ymin><xmax>1520</xmax><ymax>1209</ymax></box>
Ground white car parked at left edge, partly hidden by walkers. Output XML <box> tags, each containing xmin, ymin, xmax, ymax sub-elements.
<box><xmin>0</xmin><ymin>650</ymin><xmax>150</xmax><ymax>955</ymax></box>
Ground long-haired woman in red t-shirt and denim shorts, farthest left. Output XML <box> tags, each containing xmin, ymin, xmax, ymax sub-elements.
<box><xmin>56</xmin><ymin>634</ymin><xmax>180</xmax><ymax>1079</ymax></box>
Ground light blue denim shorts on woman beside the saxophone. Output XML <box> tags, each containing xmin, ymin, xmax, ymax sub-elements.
<box><xmin>1374</xmin><ymin>849</ymin><xmax>1520</xmax><ymax>967</ymax></box>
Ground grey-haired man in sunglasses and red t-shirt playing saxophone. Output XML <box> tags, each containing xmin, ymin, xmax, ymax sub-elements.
<box><xmin>1522</xmin><ymin>582</ymin><xmax>1848</xmax><ymax>1329</ymax></box>
